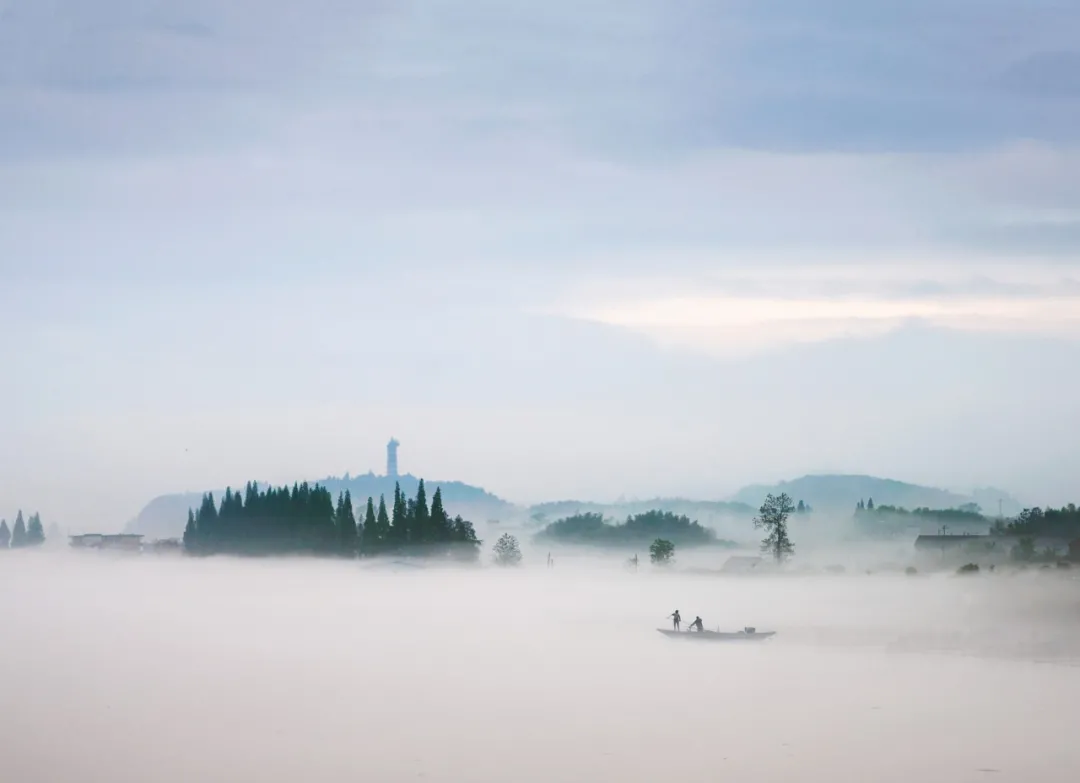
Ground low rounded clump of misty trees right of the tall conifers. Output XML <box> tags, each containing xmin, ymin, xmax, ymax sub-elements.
<box><xmin>537</xmin><ymin>511</ymin><xmax>734</xmax><ymax>546</ymax></box>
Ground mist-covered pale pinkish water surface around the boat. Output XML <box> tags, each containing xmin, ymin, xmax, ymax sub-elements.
<box><xmin>0</xmin><ymin>552</ymin><xmax>1080</xmax><ymax>783</ymax></box>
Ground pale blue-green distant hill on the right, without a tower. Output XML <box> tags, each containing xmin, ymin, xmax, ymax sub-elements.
<box><xmin>731</xmin><ymin>475</ymin><xmax>1020</xmax><ymax>515</ymax></box>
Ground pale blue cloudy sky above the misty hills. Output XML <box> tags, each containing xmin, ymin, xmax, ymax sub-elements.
<box><xmin>0</xmin><ymin>0</ymin><xmax>1080</xmax><ymax>526</ymax></box>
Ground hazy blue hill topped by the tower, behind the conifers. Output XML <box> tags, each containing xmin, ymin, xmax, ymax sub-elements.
<box><xmin>124</xmin><ymin>473</ymin><xmax>517</xmax><ymax>539</ymax></box>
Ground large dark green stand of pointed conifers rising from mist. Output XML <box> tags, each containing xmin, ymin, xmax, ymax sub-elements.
<box><xmin>184</xmin><ymin>480</ymin><xmax>481</xmax><ymax>561</ymax></box>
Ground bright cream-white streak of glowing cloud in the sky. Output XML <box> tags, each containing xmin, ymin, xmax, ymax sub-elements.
<box><xmin>553</xmin><ymin>267</ymin><xmax>1080</xmax><ymax>355</ymax></box>
